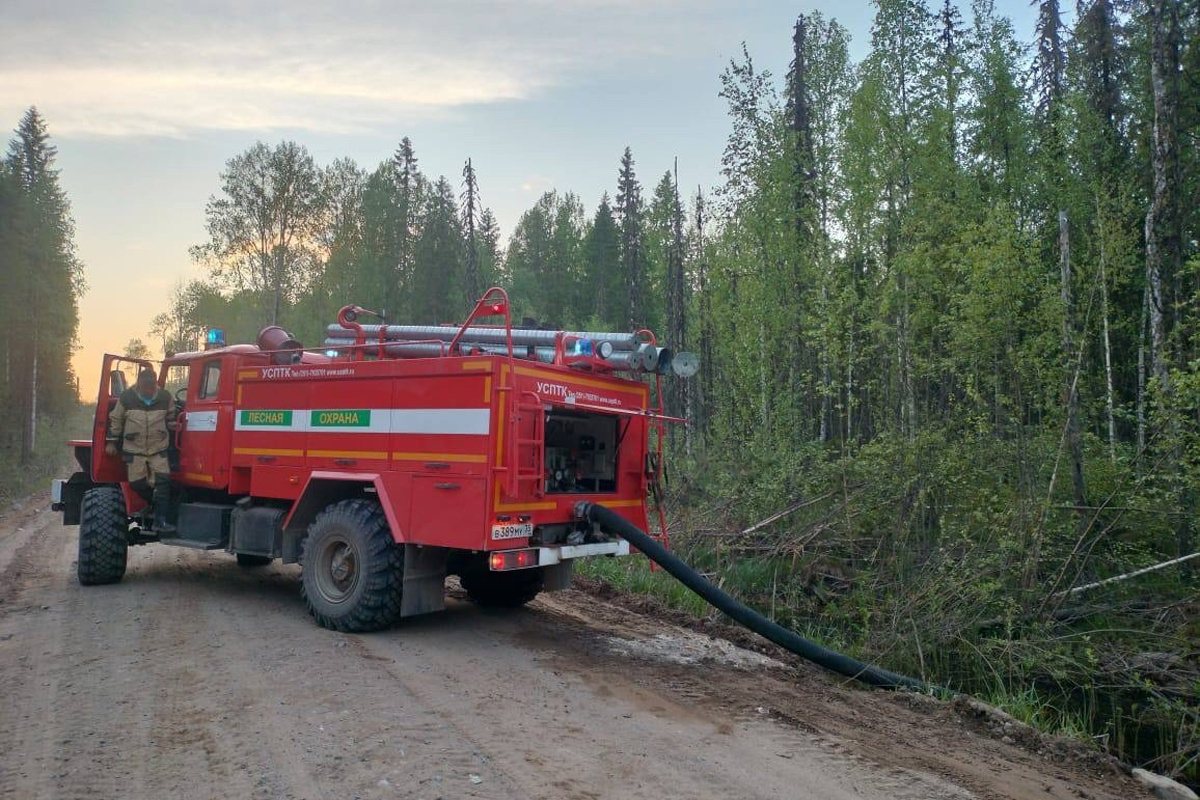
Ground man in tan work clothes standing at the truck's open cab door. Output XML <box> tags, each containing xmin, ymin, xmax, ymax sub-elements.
<box><xmin>104</xmin><ymin>369</ymin><xmax>175</xmax><ymax>536</ymax></box>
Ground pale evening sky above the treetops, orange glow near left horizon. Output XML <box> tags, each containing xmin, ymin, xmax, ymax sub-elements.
<box><xmin>0</xmin><ymin>0</ymin><xmax>1033</xmax><ymax>398</ymax></box>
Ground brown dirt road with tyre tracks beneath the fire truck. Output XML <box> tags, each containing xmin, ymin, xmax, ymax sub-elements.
<box><xmin>0</xmin><ymin>509</ymin><xmax>1144</xmax><ymax>800</ymax></box>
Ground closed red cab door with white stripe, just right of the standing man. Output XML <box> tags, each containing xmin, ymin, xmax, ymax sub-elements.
<box><xmin>179</xmin><ymin>356</ymin><xmax>233</xmax><ymax>489</ymax></box>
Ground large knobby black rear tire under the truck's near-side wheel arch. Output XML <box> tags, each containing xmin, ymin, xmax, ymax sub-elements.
<box><xmin>300</xmin><ymin>500</ymin><xmax>404</xmax><ymax>633</ymax></box>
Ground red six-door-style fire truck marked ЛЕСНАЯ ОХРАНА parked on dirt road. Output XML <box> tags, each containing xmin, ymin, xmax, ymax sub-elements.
<box><xmin>53</xmin><ymin>289</ymin><xmax>696</xmax><ymax>631</ymax></box>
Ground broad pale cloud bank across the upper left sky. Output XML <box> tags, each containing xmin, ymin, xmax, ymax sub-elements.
<box><xmin>0</xmin><ymin>0</ymin><xmax>710</xmax><ymax>137</ymax></box>
